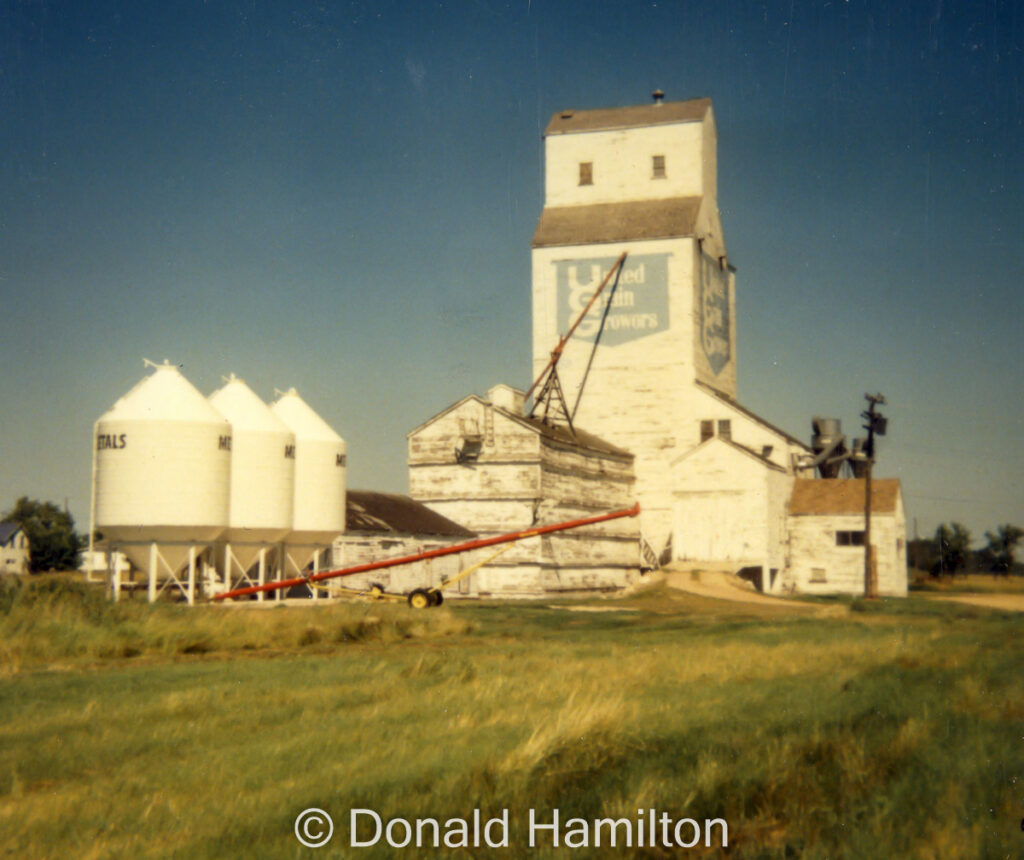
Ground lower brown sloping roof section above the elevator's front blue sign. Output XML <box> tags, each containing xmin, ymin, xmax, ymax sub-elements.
<box><xmin>532</xmin><ymin>197</ymin><xmax>700</xmax><ymax>248</ymax></box>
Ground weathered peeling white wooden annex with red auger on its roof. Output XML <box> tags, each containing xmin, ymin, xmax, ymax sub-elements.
<box><xmin>409</xmin><ymin>386</ymin><xmax>640</xmax><ymax>597</ymax></box>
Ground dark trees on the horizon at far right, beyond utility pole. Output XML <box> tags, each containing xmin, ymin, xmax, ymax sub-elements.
<box><xmin>906</xmin><ymin>522</ymin><xmax>1024</xmax><ymax>576</ymax></box>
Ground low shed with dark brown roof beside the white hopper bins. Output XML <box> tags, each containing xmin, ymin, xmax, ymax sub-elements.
<box><xmin>326</xmin><ymin>489</ymin><xmax>476</xmax><ymax>594</ymax></box>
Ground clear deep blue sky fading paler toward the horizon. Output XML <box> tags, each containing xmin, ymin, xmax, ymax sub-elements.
<box><xmin>0</xmin><ymin>0</ymin><xmax>1024</xmax><ymax>538</ymax></box>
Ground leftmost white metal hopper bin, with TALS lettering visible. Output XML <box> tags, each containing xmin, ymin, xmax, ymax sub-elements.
<box><xmin>93</xmin><ymin>361</ymin><xmax>231</xmax><ymax>599</ymax></box>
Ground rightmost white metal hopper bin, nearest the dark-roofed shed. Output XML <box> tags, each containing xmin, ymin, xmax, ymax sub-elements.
<box><xmin>270</xmin><ymin>388</ymin><xmax>346</xmax><ymax>570</ymax></box>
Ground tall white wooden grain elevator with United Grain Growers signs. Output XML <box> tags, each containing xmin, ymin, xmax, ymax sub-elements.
<box><xmin>532</xmin><ymin>92</ymin><xmax>806</xmax><ymax>560</ymax></box>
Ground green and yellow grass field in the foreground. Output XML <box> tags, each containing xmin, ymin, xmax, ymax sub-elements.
<box><xmin>0</xmin><ymin>583</ymin><xmax>1024</xmax><ymax>858</ymax></box>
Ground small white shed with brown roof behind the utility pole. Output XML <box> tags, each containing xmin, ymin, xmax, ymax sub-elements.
<box><xmin>782</xmin><ymin>478</ymin><xmax>907</xmax><ymax>597</ymax></box>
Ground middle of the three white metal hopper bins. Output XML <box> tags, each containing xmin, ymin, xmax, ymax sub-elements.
<box><xmin>210</xmin><ymin>374</ymin><xmax>295</xmax><ymax>578</ymax></box>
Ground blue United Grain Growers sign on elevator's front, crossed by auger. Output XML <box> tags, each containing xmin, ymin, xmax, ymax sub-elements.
<box><xmin>554</xmin><ymin>254</ymin><xmax>669</xmax><ymax>346</ymax></box>
